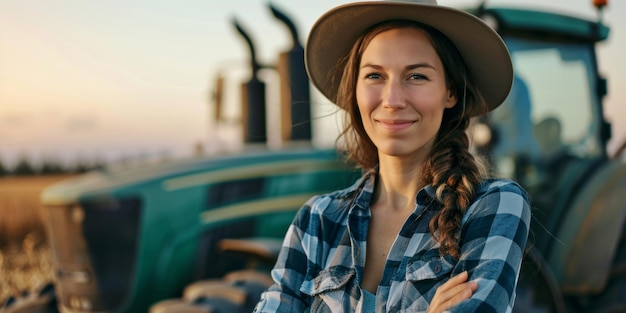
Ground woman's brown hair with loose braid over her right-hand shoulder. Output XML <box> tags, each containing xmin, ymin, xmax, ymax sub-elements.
<box><xmin>414</xmin><ymin>20</ymin><xmax>488</xmax><ymax>258</ymax></box>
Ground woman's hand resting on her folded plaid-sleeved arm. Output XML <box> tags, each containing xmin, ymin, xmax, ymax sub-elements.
<box><xmin>426</xmin><ymin>271</ymin><xmax>478</xmax><ymax>313</ymax></box>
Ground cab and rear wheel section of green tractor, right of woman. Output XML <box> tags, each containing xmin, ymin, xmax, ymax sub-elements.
<box><xmin>473</xmin><ymin>3</ymin><xmax>626</xmax><ymax>312</ymax></box>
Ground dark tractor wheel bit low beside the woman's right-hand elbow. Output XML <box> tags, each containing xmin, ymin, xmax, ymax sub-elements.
<box><xmin>513</xmin><ymin>247</ymin><xmax>566</xmax><ymax>313</ymax></box>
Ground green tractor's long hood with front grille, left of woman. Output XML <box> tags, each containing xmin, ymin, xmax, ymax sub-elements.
<box><xmin>42</xmin><ymin>149</ymin><xmax>356</xmax><ymax>312</ymax></box>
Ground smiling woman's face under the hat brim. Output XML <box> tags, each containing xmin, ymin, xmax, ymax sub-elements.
<box><xmin>356</xmin><ymin>28</ymin><xmax>456</xmax><ymax>158</ymax></box>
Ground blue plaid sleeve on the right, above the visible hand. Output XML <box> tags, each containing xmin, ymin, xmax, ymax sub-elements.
<box><xmin>450</xmin><ymin>180</ymin><xmax>530</xmax><ymax>313</ymax></box>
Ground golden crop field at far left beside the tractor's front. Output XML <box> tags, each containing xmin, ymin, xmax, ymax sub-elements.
<box><xmin>0</xmin><ymin>175</ymin><xmax>73</xmax><ymax>306</ymax></box>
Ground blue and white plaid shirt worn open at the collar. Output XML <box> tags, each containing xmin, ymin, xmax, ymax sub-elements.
<box><xmin>255</xmin><ymin>175</ymin><xmax>530</xmax><ymax>313</ymax></box>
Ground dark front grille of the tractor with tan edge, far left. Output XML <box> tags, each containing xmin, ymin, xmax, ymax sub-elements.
<box><xmin>49</xmin><ymin>198</ymin><xmax>141</xmax><ymax>311</ymax></box>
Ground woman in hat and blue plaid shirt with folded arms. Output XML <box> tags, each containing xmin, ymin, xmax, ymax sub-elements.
<box><xmin>255</xmin><ymin>1</ymin><xmax>530</xmax><ymax>313</ymax></box>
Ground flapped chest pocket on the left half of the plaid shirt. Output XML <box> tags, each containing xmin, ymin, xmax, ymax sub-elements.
<box><xmin>300</xmin><ymin>266</ymin><xmax>356</xmax><ymax>312</ymax></box>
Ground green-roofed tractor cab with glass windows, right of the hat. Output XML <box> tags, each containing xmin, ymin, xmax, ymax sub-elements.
<box><xmin>473</xmin><ymin>7</ymin><xmax>610</xmax><ymax>254</ymax></box>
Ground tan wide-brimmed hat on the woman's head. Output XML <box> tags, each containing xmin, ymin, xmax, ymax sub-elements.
<box><xmin>305</xmin><ymin>0</ymin><xmax>513</xmax><ymax>114</ymax></box>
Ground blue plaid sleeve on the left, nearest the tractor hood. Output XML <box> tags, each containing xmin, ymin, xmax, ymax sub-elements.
<box><xmin>254</xmin><ymin>197</ymin><xmax>316</xmax><ymax>313</ymax></box>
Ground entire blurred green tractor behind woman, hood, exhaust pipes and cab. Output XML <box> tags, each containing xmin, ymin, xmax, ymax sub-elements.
<box><xmin>0</xmin><ymin>1</ymin><xmax>626</xmax><ymax>313</ymax></box>
